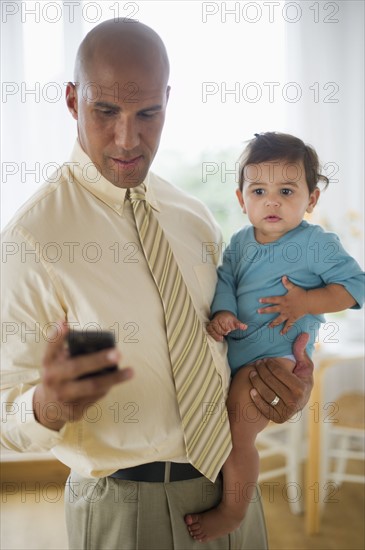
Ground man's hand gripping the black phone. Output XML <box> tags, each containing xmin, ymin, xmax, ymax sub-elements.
<box><xmin>33</xmin><ymin>322</ymin><xmax>133</xmax><ymax>430</ymax></box>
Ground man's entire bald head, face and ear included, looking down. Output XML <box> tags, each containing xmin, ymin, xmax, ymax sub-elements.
<box><xmin>66</xmin><ymin>19</ymin><xmax>170</xmax><ymax>188</ymax></box>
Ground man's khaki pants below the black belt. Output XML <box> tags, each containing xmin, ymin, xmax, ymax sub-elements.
<box><xmin>65</xmin><ymin>472</ymin><xmax>267</xmax><ymax>550</ymax></box>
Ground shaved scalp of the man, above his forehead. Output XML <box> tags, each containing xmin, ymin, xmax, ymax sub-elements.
<box><xmin>74</xmin><ymin>19</ymin><xmax>169</xmax><ymax>85</ymax></box>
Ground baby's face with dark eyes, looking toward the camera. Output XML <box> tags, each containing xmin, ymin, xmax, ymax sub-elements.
<box><xmin>237</xmin><ymin>160</ymin><xmax>319</xmax><ymax>243</ymax></box>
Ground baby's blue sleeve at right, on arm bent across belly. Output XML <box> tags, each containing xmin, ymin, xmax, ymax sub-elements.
<box><xmin>308</xmin><ymin>226</ymin><xmax>365</xmax><ymax>309</ymax></box>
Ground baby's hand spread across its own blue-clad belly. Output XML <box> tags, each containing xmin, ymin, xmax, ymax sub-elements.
<box><xmin>257</xmin><ymin>276</ymin><xmax>308</xmax><ymax>334</ymax></box>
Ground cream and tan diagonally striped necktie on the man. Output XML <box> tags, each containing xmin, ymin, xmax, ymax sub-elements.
<box><xmin>127</xmin><ymin>184</ymin><xmax>231</xmax><ymax>480</ymax></box>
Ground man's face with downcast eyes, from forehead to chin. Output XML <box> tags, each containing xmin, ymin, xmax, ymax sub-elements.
<box><xmin>67</xmin><ymin>58</ymin><xmax>169</xmax><ymax>188</ymax></box>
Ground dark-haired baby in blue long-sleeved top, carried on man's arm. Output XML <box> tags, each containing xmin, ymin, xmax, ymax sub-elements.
<box><xmin>185</xmin><ymin>132</ymin><xmax>365</xmax><ymax>542</ymax></box>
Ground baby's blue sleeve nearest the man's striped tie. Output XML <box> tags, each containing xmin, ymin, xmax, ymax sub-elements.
<box><xmin>211</xmin><ymin>236</ymin><xmax>238</xmax><ymax>316</ymax></box>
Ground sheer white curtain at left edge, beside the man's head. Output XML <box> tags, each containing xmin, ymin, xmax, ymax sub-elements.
<box><xmin>1</xmin><ymin>1</ymin><xmax>82</xmax><ymax>227</ymax></box>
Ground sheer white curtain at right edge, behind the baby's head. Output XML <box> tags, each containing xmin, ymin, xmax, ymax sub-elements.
<box><xmin>286</xmin><ymin>0</ymin><xmax>364</xmax><ymax>263</ymax></box>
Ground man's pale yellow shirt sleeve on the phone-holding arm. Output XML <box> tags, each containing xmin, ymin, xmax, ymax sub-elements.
<box><xmin>0</xmin><ymin>227</ymin><xmax>65</xmax><ymax>451</ymax></box>
